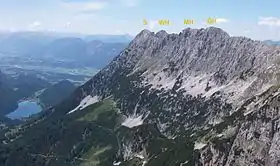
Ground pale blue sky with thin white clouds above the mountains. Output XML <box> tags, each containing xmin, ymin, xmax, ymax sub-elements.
<box><xmin>0</xmin><ymin>0</ymin><xmax>280</xmax><ymax>40</ymax></box>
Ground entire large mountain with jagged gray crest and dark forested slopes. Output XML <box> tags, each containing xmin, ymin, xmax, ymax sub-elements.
<box><xmin>0</xmin><ymin>27</ymin><xmax>280</xmax><ymax>166</ymax></box>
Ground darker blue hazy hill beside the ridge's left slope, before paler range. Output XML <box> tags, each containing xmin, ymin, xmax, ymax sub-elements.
<box><xmin>43</xmin><ymin>38</ymin><xmax>128</xmax><ymax>68</ymax></box>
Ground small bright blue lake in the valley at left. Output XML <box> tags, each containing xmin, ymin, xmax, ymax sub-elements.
<box><xmin>6</xmin><ymin>101</ymin><xmax>42</xmax><ymax>119</ymax></box>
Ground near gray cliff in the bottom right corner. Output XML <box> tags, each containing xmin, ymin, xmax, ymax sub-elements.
<box><xmin>197</xmin><ymin>86</ymin><xmax>280</xmax><ymax>166</ymax></box>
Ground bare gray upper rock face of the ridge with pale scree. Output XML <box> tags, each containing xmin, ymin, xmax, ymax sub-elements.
<box><xmin>113</xmin><ymin>27</ymin><xmax>280</xmax><ymax>102</ymax></box>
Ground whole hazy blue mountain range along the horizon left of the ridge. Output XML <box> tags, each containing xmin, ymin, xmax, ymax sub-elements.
<box><xmin>0</xmin><ymin>32</ymin><xmax>132</xmax><ymax>68</ymax></box>
